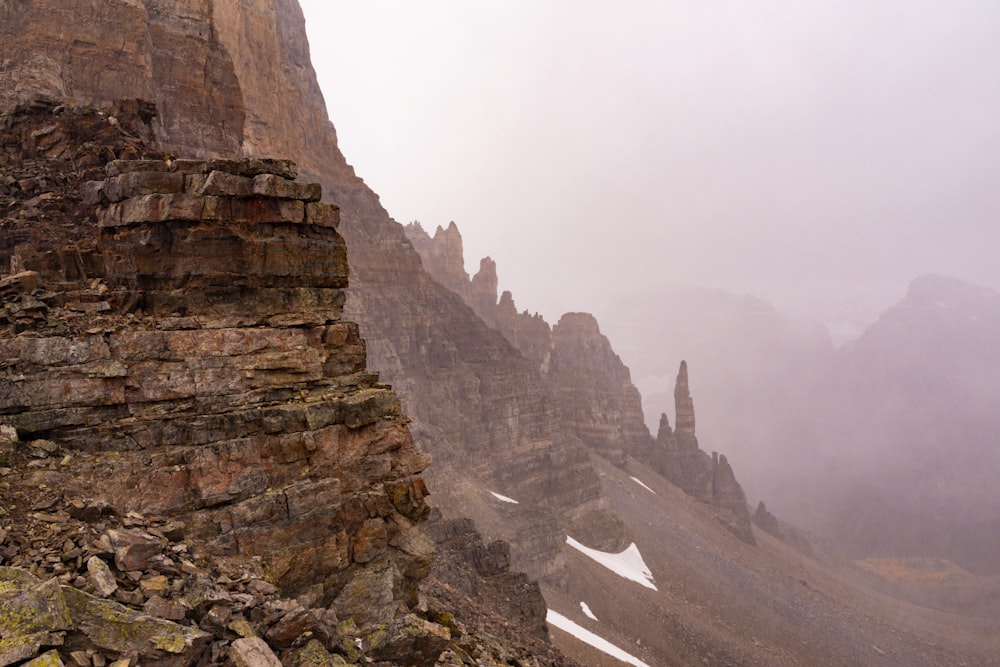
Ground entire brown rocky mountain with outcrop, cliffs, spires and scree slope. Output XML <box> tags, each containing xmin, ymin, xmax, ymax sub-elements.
<box><xmin>0</xmin><ymin>0</ymin><xmax>996</xmax><ymax>666</ymax></box>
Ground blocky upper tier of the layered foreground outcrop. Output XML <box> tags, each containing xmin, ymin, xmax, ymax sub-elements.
<box><xmin>90</xmin><ymin>159</ymin><xmax>347</xmax><ymax>324</ymax></box>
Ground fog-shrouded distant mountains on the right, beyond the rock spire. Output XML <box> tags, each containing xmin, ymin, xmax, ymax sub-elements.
<box><xmin>592</xmin><ymin>276</ymin><xmax>1000</xmax><ymax>574</ymax></box>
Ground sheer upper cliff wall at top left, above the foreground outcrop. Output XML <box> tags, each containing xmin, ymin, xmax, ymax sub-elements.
<box><xmin>0</xmin><ymin>0</ymin><xmax>353</xmax><ymax>179</ymax></box>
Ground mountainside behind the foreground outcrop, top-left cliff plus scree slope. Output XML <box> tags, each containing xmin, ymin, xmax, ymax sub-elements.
<box><xmin>0</xmin><ymin>0</ymin><xmax>993</xmax><ymax>665</ymax></box>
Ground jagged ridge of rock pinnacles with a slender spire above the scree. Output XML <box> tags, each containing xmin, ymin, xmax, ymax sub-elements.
<box><xmin>406</xmin><ymin>223</ymin><xmax>755</xmax><ymax>544</ymax></box>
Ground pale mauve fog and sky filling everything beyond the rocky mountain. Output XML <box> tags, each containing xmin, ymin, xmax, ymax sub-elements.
<box><xmin>302</xmin><ymin>0</ymin><xmax>1000</xmax><ymax>572</ymax></box>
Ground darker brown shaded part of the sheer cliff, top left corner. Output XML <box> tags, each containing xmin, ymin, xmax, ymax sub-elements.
<box><xmin>0</xmin><ymin>0</ymin><xmax>246</xmax><ymax>155</ymax></box>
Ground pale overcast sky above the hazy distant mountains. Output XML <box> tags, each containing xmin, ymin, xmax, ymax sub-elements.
<box><xmin>301</xmin><ymin>0</ymin><xmax>1000</xmax><ymax>332</ymax></box>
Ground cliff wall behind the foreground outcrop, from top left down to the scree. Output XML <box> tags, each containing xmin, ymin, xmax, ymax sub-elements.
<box><xmin>0</xmin><ymin>0</ymin><xmax>622</xmax><ymax>578</ymax></box>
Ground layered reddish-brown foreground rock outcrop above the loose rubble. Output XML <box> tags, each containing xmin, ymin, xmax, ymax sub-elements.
<box><xmin>0</xmin><ymin>159</ymin><xmax>432</xmax><ymax>623</ymax></box>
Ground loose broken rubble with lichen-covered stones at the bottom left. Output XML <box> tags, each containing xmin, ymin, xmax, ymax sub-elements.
<box><xmin>0</xmin><ymin>456</ymin><xmax>452</xmax><ymax>666</ymax></box>
